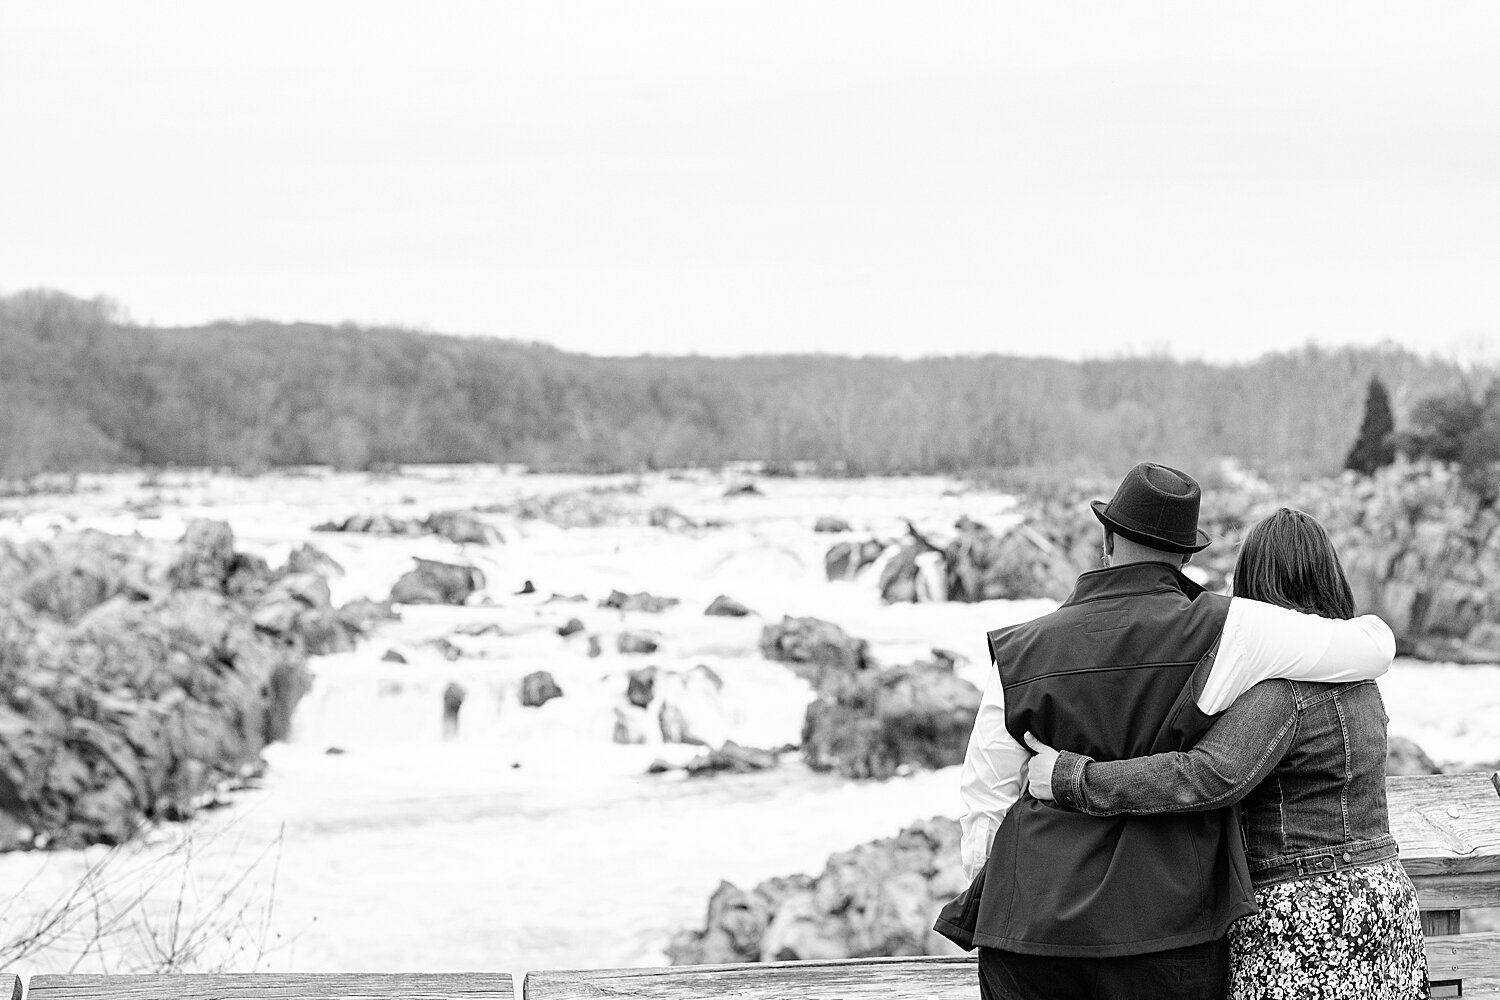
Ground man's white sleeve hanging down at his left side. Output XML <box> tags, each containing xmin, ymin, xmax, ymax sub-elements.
<box><xmin>959</xmin><ymin>670</ymin><xmax>1031</xmax><ymax>879</ymax></box>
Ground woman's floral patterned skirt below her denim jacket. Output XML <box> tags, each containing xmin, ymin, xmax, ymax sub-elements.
<box><xmin>1229</xmin><ymin>859</ymin><xmax>1427</xmax><ymax>1000</ymax></box>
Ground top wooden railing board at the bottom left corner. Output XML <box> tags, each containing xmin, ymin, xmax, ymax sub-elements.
<box><xmin>26</xmin><ymin>973</ymin><xmax>515</xmax><ymax>1000</ymax></box>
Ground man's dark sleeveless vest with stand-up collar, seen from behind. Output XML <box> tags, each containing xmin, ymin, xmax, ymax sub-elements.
<box><xmin>974</xmin><ymin>562</ymin><xmax>1256</xmax><ymax>958</ymax></box>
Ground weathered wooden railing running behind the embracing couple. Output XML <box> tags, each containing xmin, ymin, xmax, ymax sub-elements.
<box><xmin>0</xmin><ymin>774</ymin><xmax>1500</xmax><ymax>1000</ymax></box>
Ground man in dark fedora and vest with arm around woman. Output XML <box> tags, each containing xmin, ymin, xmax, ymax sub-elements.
<box><xmin>936</xmin><ymin>462</ymin><xmax>1395</xmax><ymax>1000</ymax></box>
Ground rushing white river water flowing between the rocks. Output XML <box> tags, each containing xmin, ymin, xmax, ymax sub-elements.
<box><xmin>0</xmin><ymin>469</ymin><xmax>1500</xmax><ymax>973</ymax></box>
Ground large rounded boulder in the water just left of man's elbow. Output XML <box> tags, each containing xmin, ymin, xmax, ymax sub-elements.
<box><xmin>803</xmin><ymin>664</ymin><xmax>980</xmax><ymax>778</ymax></box>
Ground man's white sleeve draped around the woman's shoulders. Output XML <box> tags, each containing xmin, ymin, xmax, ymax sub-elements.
<box><xmin>1199</xmin><ymin>597</ymin><xmax>1397</xmax><ymax>715</ymax></box>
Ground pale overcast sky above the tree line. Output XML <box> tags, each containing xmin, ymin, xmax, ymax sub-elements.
<box><xmin>0</xmin><ymin>0</ymin><xmax>1500</xmax><ymax>358</ymax></box>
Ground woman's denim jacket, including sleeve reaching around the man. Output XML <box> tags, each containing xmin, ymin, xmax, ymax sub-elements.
<box><xmin>1053</xmin><ymin>681</ymin><xmax>1397</xmax><ymax>886</ymax></box>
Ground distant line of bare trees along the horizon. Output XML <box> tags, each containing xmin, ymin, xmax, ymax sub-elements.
<box><xmin>0</xmin><ymin>291</ymin><xmax>1476</xmax><ymax>477</ymax></box>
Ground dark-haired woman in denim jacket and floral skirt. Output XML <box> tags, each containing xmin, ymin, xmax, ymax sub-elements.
<box><xmin>1028</xmin><ymin>507</ymin><xmax>1427</xmax><ymax>1000</ymax></box>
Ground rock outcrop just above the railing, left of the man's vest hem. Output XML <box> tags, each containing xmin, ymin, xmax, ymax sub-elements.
<box><xmin>668</xmin><ymin>819</ymin><xmax>968</xmax><ymax>966</ymax></box>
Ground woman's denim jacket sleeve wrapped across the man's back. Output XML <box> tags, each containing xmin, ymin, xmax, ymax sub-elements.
<box><xmin>1052</xmin><ymin>681</ymin><xmax>1298</xmax><ymax>816</ymax></box>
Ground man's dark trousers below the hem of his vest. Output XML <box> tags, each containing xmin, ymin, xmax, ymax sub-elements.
<box><xmin>980</xmin><ymin>937</ymin><xmax>1229</xmax><ymax>1000</ymax></box>
